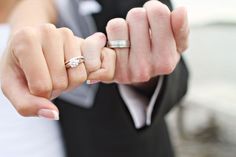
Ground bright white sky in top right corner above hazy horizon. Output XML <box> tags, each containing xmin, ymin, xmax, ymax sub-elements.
<box><xmin>172</xmin><ymin>0</ymin><xmax>236</xmax><ymax>25</ymax></box>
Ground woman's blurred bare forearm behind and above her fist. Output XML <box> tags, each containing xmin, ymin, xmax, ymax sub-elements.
<box><xmin>8</xmin><ymin>0</ymin><xmax>57</xmax><ymax>34</ymax></box>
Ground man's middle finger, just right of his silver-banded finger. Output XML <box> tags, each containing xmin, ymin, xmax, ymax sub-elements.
<box><xmin>126</xmin><ymin>8</ymin><xmax>151</xmax><ymax>82</ymax></box>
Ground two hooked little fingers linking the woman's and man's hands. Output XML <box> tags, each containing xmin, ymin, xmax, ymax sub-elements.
<box><xmin>81</xmin><ymin>33</ymin><xmax>116</xmax><ymax>83</ymax></box>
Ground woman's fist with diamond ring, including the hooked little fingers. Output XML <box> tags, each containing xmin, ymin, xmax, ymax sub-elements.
<box><xmin>1</xmin><ymin>24</ymin><xmax>115</xmax><ymax>119</ymax></box>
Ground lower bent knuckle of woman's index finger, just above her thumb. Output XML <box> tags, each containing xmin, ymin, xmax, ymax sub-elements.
<box><xmin>29</xmin><ymin>81</ymin><xmax>52</xmax><ymax>98</ymax></box>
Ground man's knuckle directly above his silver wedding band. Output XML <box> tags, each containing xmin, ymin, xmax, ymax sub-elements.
<box><xmin>106</xmin><ymin>18</ymin><xmax>127</xmax><ymax>32</ymax></box>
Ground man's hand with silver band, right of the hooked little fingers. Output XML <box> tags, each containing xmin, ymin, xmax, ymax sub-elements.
<box><xmin>106</xmin><ymin>1</ymin><xmax>189</xmax><ymax>84</ymax></box>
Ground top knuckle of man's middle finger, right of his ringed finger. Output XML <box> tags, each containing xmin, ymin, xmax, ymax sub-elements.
<box><xmin>126</xmin><ymin>8</ymin><xmax>146</xmax><ymax>21</ymax></box>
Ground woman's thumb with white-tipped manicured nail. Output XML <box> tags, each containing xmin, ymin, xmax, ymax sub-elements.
<box><xmin>1</xmin><ymin>67</ymin><xmax>59</xmax><ymax>120</ymax></box>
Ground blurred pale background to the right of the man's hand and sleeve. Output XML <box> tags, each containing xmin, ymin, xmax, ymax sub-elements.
<box><xmin>167</xmin><ymin>0</ymin><xmax>236</xmax><ymax>157</ymax></box>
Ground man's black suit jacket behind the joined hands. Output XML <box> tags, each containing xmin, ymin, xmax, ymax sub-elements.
<box><xmin>55</xmin><ymin>0</ymin><xmax>188</xmax><ymax>157</ymax></box>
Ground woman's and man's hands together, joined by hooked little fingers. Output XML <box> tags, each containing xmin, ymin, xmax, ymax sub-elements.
<box><xmin>1</xmin><ymin>1</ymin><xmax>189</xmax><ymax>119</ymax></box>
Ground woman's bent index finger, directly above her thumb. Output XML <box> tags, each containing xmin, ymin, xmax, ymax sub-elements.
<box><xmin>9</xmin><ymin>29</ymin><xmax>52</xmax><ymax>98</ymax></box>
